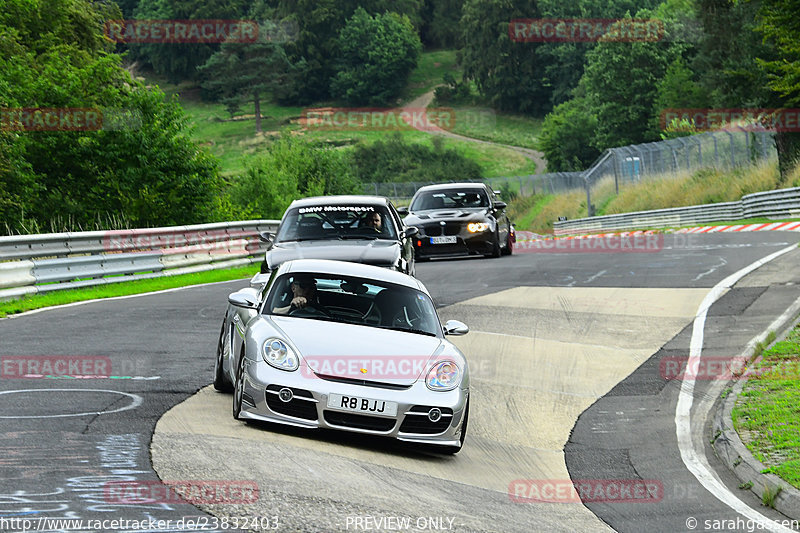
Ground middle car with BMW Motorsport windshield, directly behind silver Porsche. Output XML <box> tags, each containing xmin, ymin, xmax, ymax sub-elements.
<box><xmin>261</xmin><ymin>196</ymin><xmax>417</xmax><ymax>276</ymax></box>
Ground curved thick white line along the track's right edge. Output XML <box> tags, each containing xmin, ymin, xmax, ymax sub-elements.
<box><xmin>675</xmin><ymin>244</ymin><xmax>797</xmax><ymax>533</ymax></box>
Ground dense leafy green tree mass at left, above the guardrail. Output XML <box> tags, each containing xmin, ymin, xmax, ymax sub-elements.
<box><xmin>0</xmin><ymin>0</ymin><xmax>218</xmax><ymax>231</ymax></box>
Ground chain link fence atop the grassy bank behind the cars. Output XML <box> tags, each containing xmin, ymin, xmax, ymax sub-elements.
<box><xmin>363</xmin><ymin>128</ymin><xmax>777</xmax><ymax>206</ymax></box>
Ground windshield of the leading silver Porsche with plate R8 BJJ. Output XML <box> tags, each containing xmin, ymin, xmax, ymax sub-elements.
<box><xmin>263</xmin><ymin>273</ymin><xmax>441</xmax><ymax>337</ymax></box>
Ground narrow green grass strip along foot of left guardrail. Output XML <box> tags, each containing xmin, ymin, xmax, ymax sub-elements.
<box><xmin>0</xmin><ymin>264</ymin><xmax>258</xmax><ymax>317</ymax></box>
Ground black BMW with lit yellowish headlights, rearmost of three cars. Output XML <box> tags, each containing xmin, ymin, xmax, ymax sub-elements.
<box><xmin>399</xmin><ymin>183</ymin><xmax>515</xmax><ymax>260</ymax></box>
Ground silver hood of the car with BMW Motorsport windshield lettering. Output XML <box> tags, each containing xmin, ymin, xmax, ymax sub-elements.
<box><xmin>266</xmin><ymin>239</ymin><xmax>400</xmax><ymax>270</ymax></box>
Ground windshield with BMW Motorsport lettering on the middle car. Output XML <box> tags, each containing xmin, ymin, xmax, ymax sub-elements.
<box><xmin>276</xmin><ymin>204</ymin><xmax>397</xmax><ymax>242</ymax></box>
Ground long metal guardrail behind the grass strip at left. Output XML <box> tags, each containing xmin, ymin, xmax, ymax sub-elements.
<box><xmin>0</xmin><ymin>220</ymin><xmax>280</xmax><ymax>300</ymax></box>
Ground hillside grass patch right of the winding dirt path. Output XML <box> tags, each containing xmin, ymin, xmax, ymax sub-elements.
<box><xmin>450</xmin><ymin>107</ymin><xmax>542</xmax><ymax>150</ymax></box>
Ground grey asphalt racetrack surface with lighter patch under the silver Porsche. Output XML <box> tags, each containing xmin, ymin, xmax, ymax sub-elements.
<box><xmin>0</xmin><ymin>232</ymin><xmax>800</xmax><ymax>532</ymax></box>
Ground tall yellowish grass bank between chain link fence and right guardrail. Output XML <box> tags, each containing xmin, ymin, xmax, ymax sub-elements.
<box><xmin>509</xmin><ymin>161</ymin><xmax>800</xmax><ymax>233</ymax></box>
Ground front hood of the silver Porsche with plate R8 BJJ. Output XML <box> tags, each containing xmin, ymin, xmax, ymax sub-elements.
<box><xmin>266</xmin><ymin>315</ymin><xmax>445</xmax><ymax>386</ymax></box>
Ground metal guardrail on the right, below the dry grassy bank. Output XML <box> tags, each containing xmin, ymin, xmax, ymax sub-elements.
<box><xmin>553</xmin><ymin>187</ymin><xmax>800</xmax><ymax>235</ymax></box>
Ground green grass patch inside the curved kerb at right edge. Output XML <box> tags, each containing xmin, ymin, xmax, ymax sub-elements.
<box><xmin>733</xmin><ymin>326</ymin><xmax>800</xmax><ymax>488</ymax></box>
